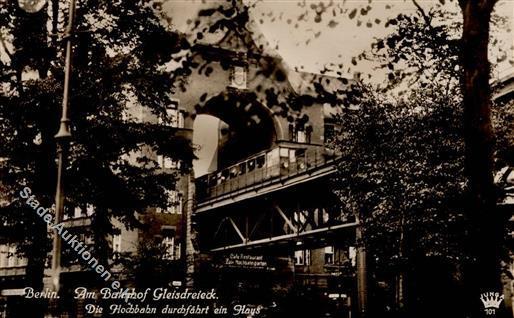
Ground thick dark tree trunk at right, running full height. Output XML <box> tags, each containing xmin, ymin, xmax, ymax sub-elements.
<box><xmin>460</xmin><ymin>0</ymin><xmax>502</xmax><ymax>317</ymax></box>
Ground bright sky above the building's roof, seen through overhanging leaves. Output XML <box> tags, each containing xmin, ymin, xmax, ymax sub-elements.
<box><xmin>165</xmin><ymin>0</ymin><xmax>514</xmax><ymax>79</ymax></box>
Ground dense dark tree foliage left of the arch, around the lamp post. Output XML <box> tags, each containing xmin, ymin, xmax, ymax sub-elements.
<box><xmin>0</xmin><ymin>0</ymin><xmax>192</xmax><ymax>306</ymax></box>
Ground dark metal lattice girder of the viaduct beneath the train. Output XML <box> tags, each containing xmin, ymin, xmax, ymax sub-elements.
<box><xmin>201</xmin><ymin>179</ymin><xmax>352</xmax><ymax>250</ymax></box>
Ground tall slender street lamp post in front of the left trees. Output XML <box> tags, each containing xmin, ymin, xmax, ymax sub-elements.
<box><xmin>52</xmin><ymin>0</ymin><xmax>76</xmax><ymax>292</ymax></box>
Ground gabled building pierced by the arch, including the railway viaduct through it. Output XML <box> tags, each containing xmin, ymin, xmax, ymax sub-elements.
<box><xmin>0</xmin><ymin>3</ymin><xmax>365</xmax><ymax>317</ymax></box>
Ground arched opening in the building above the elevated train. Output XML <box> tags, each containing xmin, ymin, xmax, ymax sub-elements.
<box><xmin>193</xmin><ymin>93</ymin><xmax>276</xmax><ymax>178</ymax></box>
